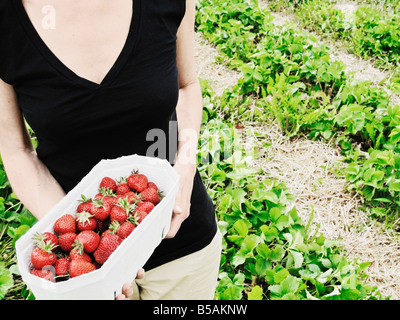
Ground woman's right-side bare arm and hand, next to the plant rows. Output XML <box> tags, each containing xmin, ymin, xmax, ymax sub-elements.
<box><xmin>167</xmin><ymin>0</ymin><xmax>203</xmax><ymax>238</ymax></box>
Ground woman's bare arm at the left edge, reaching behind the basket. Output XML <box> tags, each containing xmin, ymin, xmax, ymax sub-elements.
<box><xmin>0</xmin><ymin>80</ymin><xmax>65</xmax><ymax>219</ymax></box>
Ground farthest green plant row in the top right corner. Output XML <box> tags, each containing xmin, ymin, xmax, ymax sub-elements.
<box><xmin>267</xmin><ymin>0</ymin><xmax>400</xmax><ymax>79</ymax></box>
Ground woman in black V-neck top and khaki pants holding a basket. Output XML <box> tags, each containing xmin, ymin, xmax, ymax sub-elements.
<box><xmin>0</xmin><ymin>0</ymin><xmax>221</xmax><ymax>299</ymax></box>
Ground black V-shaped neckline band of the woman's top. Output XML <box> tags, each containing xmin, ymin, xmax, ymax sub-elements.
<box><xmin>12</xmin><ymin>0</ymin><xmax>140</xmax><ymax>89</ymax></box>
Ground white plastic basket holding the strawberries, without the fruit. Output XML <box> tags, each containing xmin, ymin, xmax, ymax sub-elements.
<box><xmin>16</xmin><ymin>155</ymin><xmax>179</xmax><ymax>300</ymax></box>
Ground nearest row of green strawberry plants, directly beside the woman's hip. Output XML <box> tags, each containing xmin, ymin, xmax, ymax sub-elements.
<box><xmin>198</xmin><ymin>83</ymin><xmax>381</xmax><ymax>300</ymax></box>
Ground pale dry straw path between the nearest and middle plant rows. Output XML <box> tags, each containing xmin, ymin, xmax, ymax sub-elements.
<box><xmin>196</xmin><ymin>31</ymin><xmax>400</xmax><ymax>300</ymax></box>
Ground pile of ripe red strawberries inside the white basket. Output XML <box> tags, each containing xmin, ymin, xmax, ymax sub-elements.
<box><xmin>31</xmin><ymin>171</ymin><xmax>163</xmax><ymax>282</ymax></box>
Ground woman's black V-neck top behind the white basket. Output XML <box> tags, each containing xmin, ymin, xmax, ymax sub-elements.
<box><xmin>0</xmin><ymin>0</ymin><xmax>217</xmax><ymax>270</ymax></box>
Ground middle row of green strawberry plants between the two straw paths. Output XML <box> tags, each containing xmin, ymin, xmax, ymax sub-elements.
<box><xmin>197</xmin><ymin>0</ymin><xmax>400</xmax><ymax>221</ymax></box>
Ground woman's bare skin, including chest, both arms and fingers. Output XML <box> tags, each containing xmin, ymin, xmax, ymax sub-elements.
<box><xmin>0</xmin><ymin>0</ymin><xmax>202</xmax><ymax>300</ymax></box>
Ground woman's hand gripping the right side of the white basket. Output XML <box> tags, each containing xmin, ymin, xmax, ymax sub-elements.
<box><xmin>166</xmin><ymin>161</ymin><xmax>196</xmax><ymax>239</ymax></box>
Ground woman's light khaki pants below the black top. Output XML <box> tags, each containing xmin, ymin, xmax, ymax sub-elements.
<box><xmin>129</xmin><ymin>230</ymin><xmax>222</xmax><ymax>300</ymax></box>
